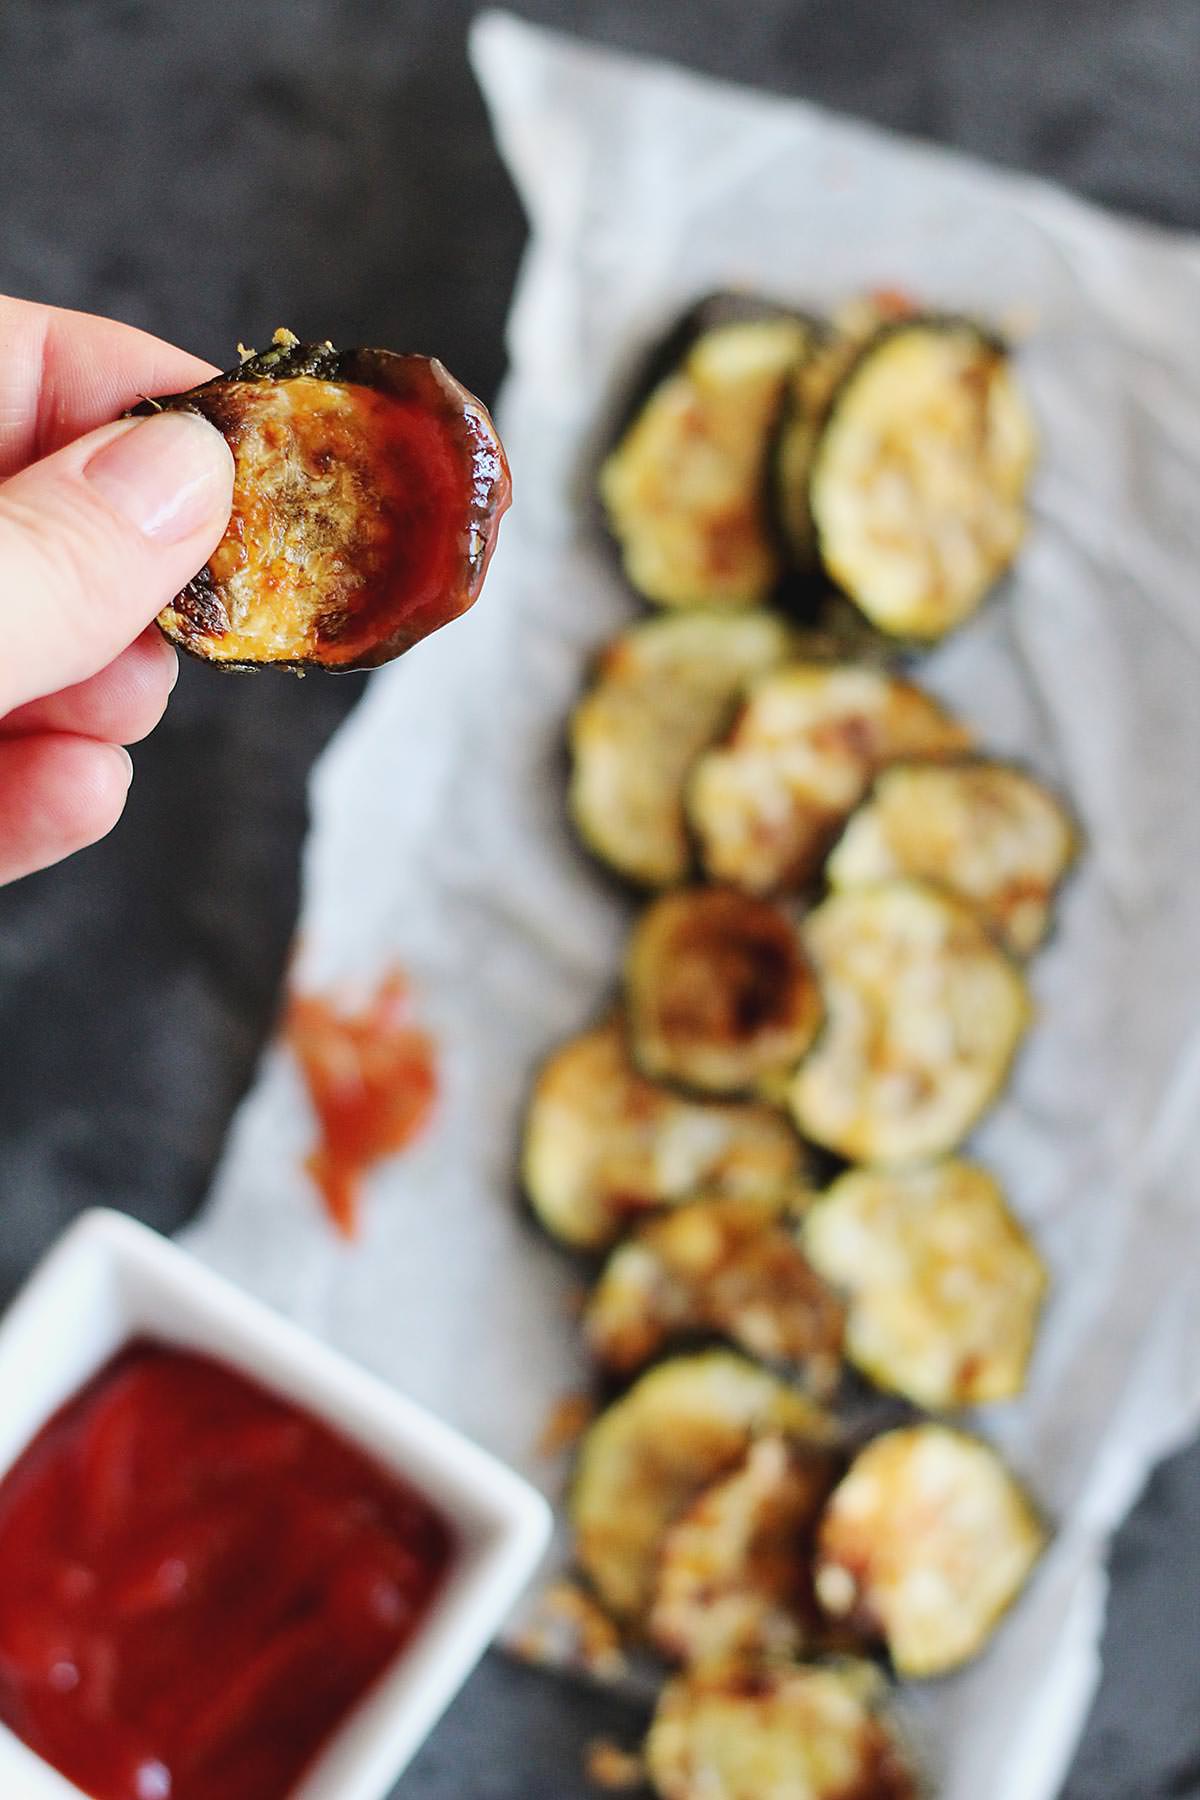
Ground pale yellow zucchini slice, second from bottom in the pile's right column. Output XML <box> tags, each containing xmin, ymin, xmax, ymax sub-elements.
<box><xmin>804</xmin><ymin>1157</ymin><xmax>1047</xmax><ymax>1411</ymax></box>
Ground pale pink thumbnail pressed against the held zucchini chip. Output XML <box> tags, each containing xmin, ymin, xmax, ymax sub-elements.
<box><xmin>83</xmin><ymin>412</ymin><xmax>232</xmax><ymax>544</ymax></box>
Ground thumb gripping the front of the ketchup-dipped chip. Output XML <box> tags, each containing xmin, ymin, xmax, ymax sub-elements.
<box><xmin>0</xmin><ymin>412</ymin><xmax>234</xmax><ymax>716</ymax></box>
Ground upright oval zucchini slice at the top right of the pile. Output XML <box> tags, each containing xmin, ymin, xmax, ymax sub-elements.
<box><xmin>810</xmin><ymin>319</ymin><xmax>1036</xmax><ymax>641</ymax></box>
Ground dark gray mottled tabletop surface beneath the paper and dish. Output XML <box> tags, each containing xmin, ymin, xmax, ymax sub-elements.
<box><xmin>0</xmin><ymin>0</ymin><xmax>1200</xmax><ymax>1800</ymax></box>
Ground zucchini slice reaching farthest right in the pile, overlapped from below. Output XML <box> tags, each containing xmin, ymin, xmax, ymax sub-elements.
<box><xmin>826</xmin><ymin>761</ymin><xmax>1076</xmax><ymax>956</ymax></box>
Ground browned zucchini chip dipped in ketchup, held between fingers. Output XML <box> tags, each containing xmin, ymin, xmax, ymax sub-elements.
<box><xmin>137</xmin><ymin>331</ymin><xmax>511</xmax><ymax>670</ymax></box>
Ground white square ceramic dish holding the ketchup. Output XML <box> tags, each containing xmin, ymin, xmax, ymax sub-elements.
<box><xmin>0</xmin><ymin>1211</ymin><xmax>551</xmax><ymax>1800</ymax></box>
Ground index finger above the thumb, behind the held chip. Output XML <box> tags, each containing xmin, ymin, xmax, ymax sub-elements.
<box><xmin>0</xmin><ymin>295</ymin><xmax>216</xmax><ymax>481</ymax></box>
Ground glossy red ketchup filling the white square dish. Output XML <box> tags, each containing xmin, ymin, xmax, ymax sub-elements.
<box><xmin>0</xmin><ymin>1343</ymin><xmax>453</xmax><ymax>1800</ymax></box>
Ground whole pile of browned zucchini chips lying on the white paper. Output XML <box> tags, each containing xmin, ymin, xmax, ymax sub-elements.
<box><xmin>524</xmin><ymin>295</ymin><xmax>1076</xmax><ymax>1800</ymax></box>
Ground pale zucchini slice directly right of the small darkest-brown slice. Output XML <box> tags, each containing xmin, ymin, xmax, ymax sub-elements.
<box><xmin>792</xmin><ymin>882</ymin><xmax>1031</xmax><ymax>1163</ymax></box>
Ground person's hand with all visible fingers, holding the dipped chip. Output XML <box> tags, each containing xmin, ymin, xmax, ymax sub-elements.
<box><xmin>0</xmin><ymin>297</ymin><xmax>234</xmax><ymax>882</ymax></box>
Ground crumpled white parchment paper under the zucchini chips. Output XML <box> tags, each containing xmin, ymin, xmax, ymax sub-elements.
<box><xmin>191</xmin><ymin>14</ymin><xmax>1200</xmax><ymax>1800</ymax></box>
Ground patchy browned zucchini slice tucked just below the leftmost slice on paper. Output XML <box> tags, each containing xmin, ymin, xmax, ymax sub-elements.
<box><xmin>583</xmin><ymin>1192</ymin><xmax>844</xmax><ymax>1399</ymax></box>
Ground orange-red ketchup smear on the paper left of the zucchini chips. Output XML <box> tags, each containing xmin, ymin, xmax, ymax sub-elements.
<box><xmin>284</xmin><ymin>970</ymin><xmax>437</xmax><ymax>1238</ymax></box>
